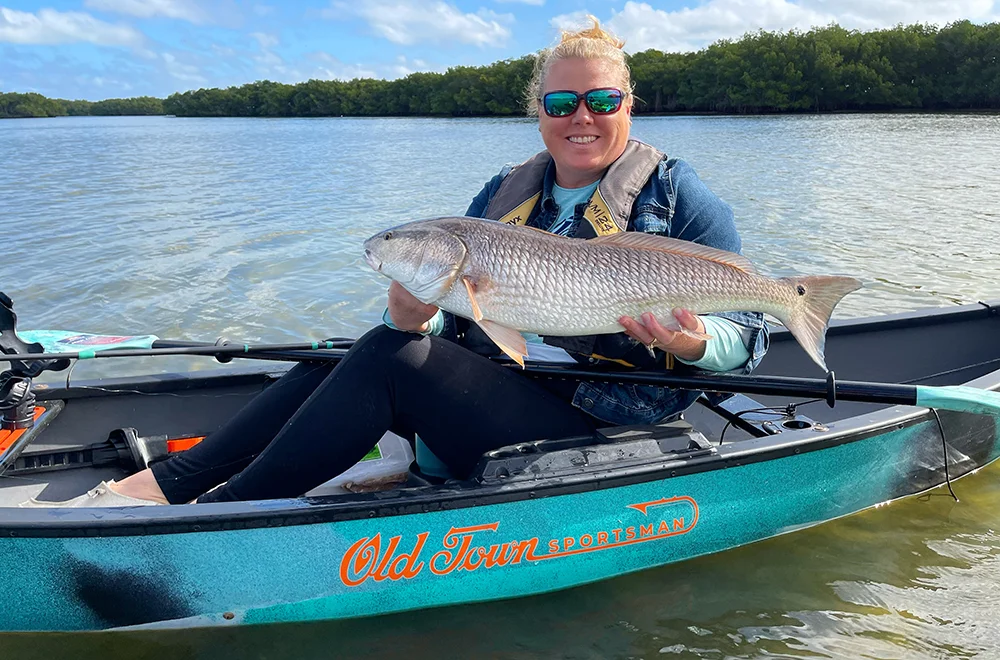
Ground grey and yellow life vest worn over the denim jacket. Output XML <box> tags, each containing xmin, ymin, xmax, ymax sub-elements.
<box><xmin>472</xmin><ymin>140</ymin><xmax>673</xmax><ymax>368</ymax></box>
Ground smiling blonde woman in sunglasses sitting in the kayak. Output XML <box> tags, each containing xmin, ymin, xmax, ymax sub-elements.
<box><xmin>29</xmin><ymin>18</ymin><xmax>767</xmax><ymax>506</ymax></box>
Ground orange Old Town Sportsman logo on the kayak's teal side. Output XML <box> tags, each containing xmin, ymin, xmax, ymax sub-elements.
<box><xmin>340</xmin><ymin>496</ymin><xmax>698</xmax><ymax>587</ymax></box>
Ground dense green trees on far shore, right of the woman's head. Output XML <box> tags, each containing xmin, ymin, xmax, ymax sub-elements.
<box><xmin>630</xmin><ymin>21</ymin><xmax>1000</xmax><ymax>113</ymax></box>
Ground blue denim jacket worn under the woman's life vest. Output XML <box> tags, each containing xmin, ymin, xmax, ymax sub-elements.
<box><xmin>458</xmin><ymin>153</ymin><xmax>768</xmax><ymax>425</ymax></box>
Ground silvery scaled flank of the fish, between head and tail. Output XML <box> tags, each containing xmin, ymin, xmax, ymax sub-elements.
<box><xmin>440</xmin><ymin>223</ymin><xmax>772</xmax><ymax>336</ymax></box>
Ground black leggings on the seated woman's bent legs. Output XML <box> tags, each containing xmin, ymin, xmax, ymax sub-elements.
<box><xmin>152</xmin><ymin>326</ymin><xmax>601</xmax><ymax>504</ymax></box>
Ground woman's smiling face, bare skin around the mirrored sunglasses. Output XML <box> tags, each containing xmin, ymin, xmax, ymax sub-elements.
<box><xmin>538</xmin><ymin>58</ymin><xmax>632</xmax><ymax>188</ymax></box>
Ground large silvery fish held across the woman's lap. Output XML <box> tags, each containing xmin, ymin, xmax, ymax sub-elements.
<box><xmin>365</xmin><ymin>218</ymin><xmax>861</xmax><ymax>369</ymax></box>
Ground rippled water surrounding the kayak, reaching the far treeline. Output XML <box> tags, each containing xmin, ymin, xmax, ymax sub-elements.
<box><xmin>0</xmin><ymin>115</ymin><xmax>1000</xmax><ymax>660</ymax></box>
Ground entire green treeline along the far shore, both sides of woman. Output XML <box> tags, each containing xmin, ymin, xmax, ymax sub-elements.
<box><xmin>0</xmin><ymin>21</ymin><xmax>1000</xmax><ymax>117</ymax></box>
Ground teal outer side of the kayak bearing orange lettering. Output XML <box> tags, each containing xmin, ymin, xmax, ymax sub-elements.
<box><xmin>0</xmin><ymin>404</ymin><xmax>998</xmax><ymax>630</ymax></box>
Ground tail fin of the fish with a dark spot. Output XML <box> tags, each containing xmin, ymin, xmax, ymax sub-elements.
<box><xmin>778</xmin><ymin>275</ymin><xmax>862</xmax><ymax>371</ymax></box>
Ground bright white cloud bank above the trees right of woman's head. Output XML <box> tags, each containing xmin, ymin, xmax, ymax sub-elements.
<box><xmin>550</xmin><ymin>0</ymin><xmax>1000</xmax><ymax>53</ymax></box>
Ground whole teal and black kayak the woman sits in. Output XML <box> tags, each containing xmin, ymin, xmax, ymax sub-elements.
<box><xmin>0</xmin><ymin>304</ymin><xmax>1000</xmax><ymax>631</ymax></box>
